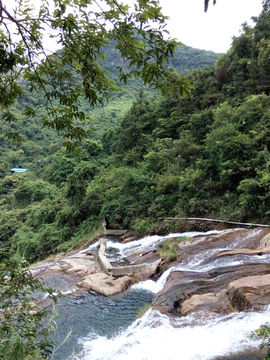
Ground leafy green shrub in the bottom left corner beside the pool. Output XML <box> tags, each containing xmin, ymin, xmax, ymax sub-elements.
<box><xmin>0</xmin><ymin>253</ymin><xmax>59</xmax><ymax>360</ymax></box>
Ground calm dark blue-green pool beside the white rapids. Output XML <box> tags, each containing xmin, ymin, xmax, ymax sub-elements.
<box><xmin>53</xmin><ymin>289</ymin><xmax>154</xmax><ymax>360</ymax></box>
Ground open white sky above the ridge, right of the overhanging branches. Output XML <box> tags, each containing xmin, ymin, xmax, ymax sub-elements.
<box><xmin>160</xmin><ymin>0</ymin><xmax>262</xmax><ymax>53</ymax></box>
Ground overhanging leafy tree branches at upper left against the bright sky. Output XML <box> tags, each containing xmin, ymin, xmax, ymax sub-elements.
<box><xmin>0</xmin><ymin>0</ymin><xmax>194</xmax><ymax>149</ymax></box>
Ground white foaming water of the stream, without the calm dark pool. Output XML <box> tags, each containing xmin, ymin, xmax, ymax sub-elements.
<box><xmin>74</xmin><ymin>229</ymin><xmax>270</xmax><ymax>360</ymax></box>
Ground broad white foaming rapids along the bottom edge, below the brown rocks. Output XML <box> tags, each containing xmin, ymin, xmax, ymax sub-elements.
<box><xmin>79</xmin><ymin>309</ymin><xmax>270</xmax><ymax>360</ymax></box>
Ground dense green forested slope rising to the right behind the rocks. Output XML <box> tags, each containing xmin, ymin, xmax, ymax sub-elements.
<box><xmin>0</xmin><ymin>1</ymin><xmax>270</xmax><ymax>261</ymax></box>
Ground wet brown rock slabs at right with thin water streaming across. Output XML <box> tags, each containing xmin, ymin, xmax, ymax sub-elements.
<box><xmin>153</xmin><ymin>229</ymin><xmax>270</xmax><ymax>316</ymax></box>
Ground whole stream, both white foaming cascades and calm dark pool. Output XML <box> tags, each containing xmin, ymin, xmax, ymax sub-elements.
<box><xmin>49</xmin><ymin>231</ymin><xmax>270</xmax><ymax>360</ymax></box>
